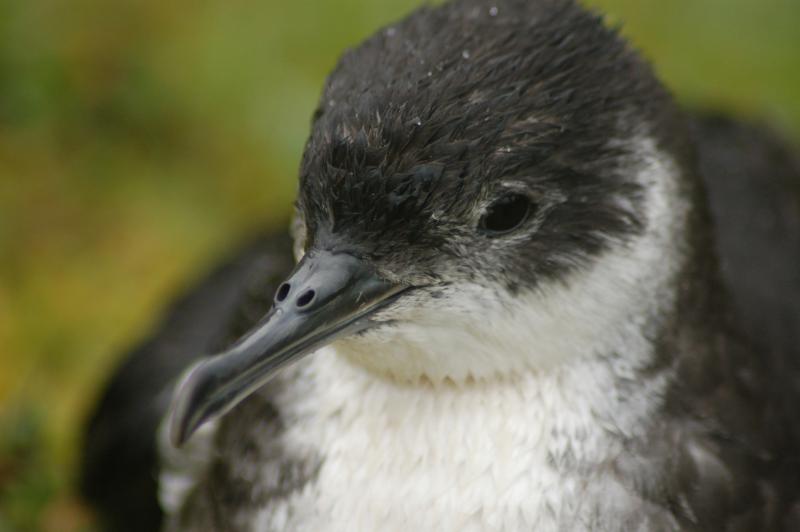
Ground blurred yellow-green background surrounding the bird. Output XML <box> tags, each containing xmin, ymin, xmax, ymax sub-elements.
<box><xmin>0</xmin><ymin>0</ymin><xmax>800</xmax><ymax>532</ymax></box>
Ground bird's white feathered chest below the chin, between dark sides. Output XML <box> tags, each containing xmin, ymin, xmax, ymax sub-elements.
<box><xmin>247</xmin><ymin>352</ymin><xmax>640</xmax><ymax>531</ymax></box>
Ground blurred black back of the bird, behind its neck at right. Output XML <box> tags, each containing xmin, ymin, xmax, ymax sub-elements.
<box><xmin>693</xmin><ymin>115</ymin><xmax>800</xmax><ymax>374</ymax></box>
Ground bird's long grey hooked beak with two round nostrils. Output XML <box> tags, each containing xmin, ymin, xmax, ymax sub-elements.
<box><xmin>170</xmin><ymin>251</ymin><xmax>403</xmax><ymax>446</ymax></box>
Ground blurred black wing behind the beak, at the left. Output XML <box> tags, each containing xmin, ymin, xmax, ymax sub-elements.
<box><xmin>81</xmin><ymin>234</ymin><xmax>293</xmax><ymax>532</ymax></box>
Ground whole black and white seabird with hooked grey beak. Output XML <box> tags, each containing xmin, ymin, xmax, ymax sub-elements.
<box><xmin>82</xmin><ymin>0</ymin><xmax>800</xmax><ymax>532</ymax></box>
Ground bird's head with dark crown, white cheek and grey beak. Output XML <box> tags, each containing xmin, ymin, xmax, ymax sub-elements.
<box><xmin>173</xmin><ymin>0</ymin><xmax>691</xmax><ymax>442</ymax></box>
